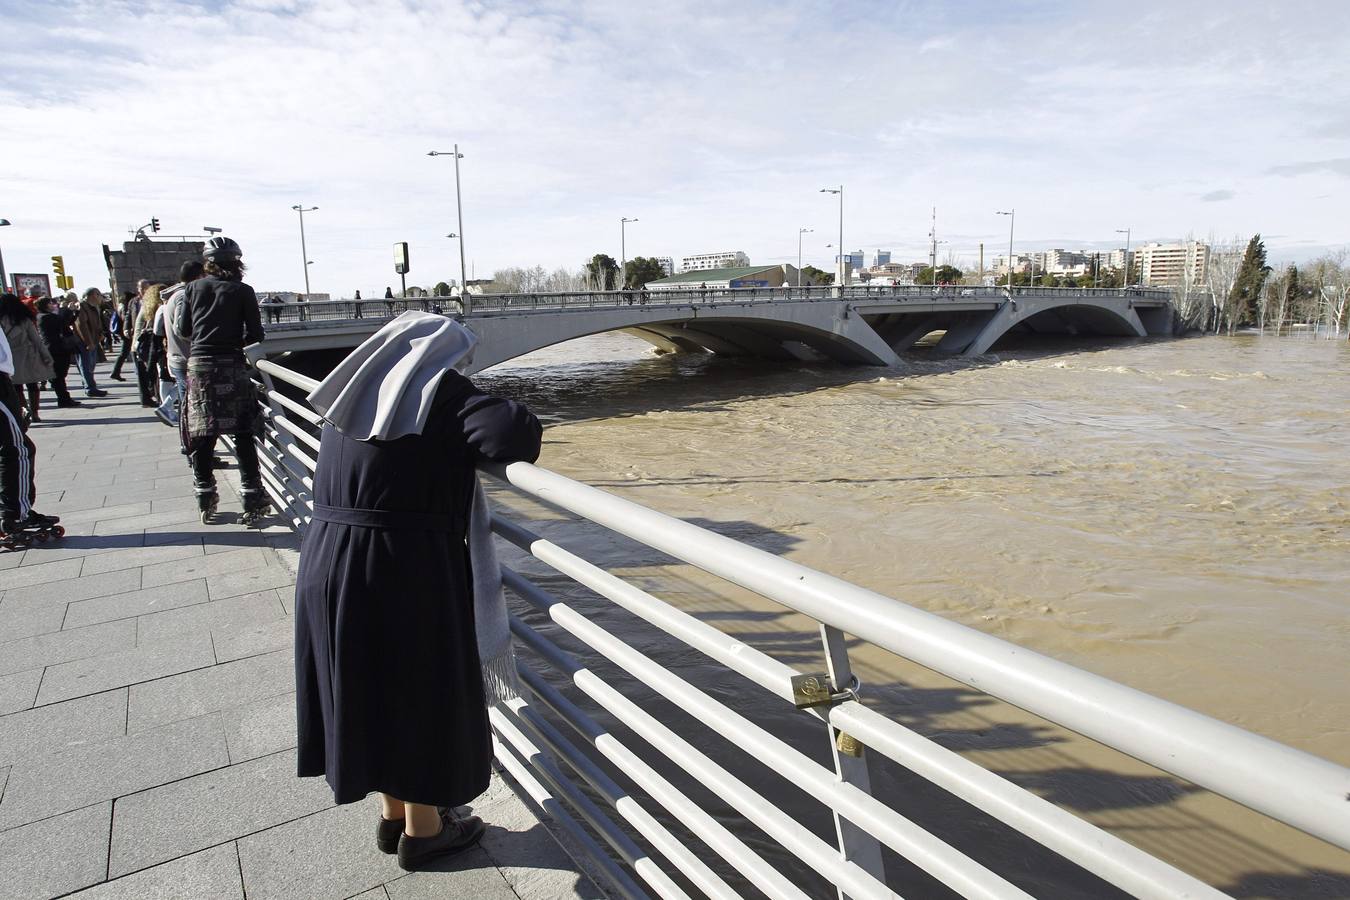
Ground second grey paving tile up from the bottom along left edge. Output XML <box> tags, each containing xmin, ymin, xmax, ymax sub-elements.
<box><xmin>0</xmin><ymin>715</ymin><xmax>228</xmax><ymax>828</ymax></box>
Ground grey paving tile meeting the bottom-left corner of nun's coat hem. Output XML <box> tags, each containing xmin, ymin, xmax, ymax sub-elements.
<box><xmin>108</xmin><ymin>750</ymin><xmax>332</xmax><ymax>877</ymax></box>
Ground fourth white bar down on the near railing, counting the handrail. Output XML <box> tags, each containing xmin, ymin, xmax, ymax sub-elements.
<box><xmin>510</xmin><ymin>615</ymin><xmax>895</xmax><ymax>900</ymax></box>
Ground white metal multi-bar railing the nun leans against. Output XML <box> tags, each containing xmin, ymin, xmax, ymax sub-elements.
<box><xmin>245</xmin><ymin>360</ymin><xmax>1350</xmax><ymax>899</ymax></box>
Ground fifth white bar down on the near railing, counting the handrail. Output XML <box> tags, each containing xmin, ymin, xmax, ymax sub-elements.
<box><xmin>516</xmin><ymin>664</ymin><xmax>807</xmax><ymax>900</ymax></box>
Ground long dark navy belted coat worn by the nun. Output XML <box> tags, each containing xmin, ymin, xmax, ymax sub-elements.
<box><xmin>296</xmin><ymin>372</ymin><xmax>541</xmax><ymax>806</ymax></box>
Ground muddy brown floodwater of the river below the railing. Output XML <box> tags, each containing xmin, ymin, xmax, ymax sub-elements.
<box><xmin>475</xmin><ymin>335</ymin><xmax>1350</xmax><ymax>897</ymax></box>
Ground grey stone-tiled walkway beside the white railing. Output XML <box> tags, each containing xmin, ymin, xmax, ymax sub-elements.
<box><xmin>0</xmin><ymin>372</ymin><xmax>599</xmax><ymax>900</ymax></box>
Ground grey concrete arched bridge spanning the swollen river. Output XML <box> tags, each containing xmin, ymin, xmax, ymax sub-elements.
<box><xmin>251</xmin><ymin>286</ymin><xmax>1172</xmax><ymax>371</ymax></box>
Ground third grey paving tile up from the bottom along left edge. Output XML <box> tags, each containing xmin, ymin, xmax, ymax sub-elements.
<box><xmin>0</xmin><ymin>688</ymin><xmax>127</xmax><ymax>765</ymax></box>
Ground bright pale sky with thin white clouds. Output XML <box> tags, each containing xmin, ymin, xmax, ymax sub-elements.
<box><xmin>0</xmin><ymin>0</ymin><xmax>1350</xmax><ymax>296</ymax></box>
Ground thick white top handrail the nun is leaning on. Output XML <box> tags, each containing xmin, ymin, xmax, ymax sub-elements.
<box><xmin>485</xmin><ymin>463</ymin><xmax>1350</xmax><ymax>849</ymax></box>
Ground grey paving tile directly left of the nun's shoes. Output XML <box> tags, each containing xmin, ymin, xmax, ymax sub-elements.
<box><xmin>239</xmin><ymin>797</ymin><xmax>396</xmax><ymax>900</ymax></box>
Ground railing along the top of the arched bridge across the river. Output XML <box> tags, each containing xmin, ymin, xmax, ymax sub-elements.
<box><xmin>263</xmin><ymin>285</ymin><xmax>1170</xmax><ymax>325</ymax></box>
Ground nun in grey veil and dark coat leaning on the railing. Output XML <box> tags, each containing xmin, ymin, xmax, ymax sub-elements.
<box><xmin>296</xmin><ymin>312</ymin><xmax>541</xmax><ymax>869</ymax></box>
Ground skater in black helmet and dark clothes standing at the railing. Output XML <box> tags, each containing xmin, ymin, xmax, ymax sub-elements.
<box><xmin>173</xmin><ymin>236</ymin><xmax>269</xmax><ymax>525</ymax></box>
